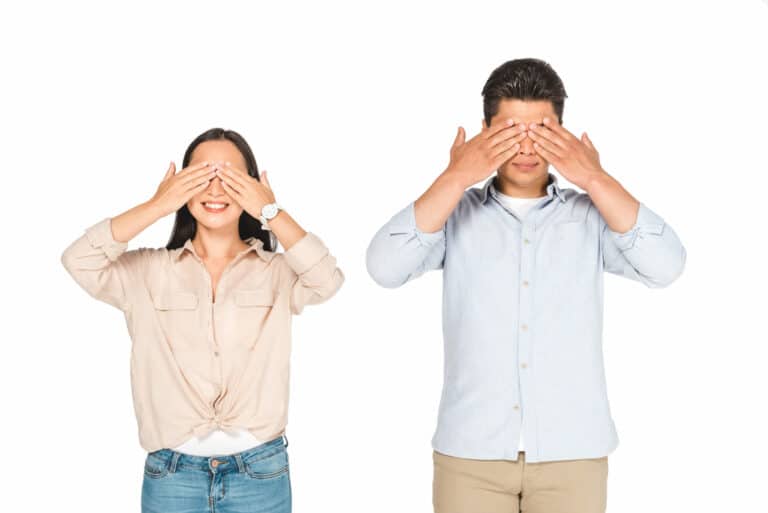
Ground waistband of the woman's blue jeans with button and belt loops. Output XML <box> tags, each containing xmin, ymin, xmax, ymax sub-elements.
<box><xmin>147</xmin><ymin>435</ymin><xmax>288</xmax><ymax>472</ymax></box>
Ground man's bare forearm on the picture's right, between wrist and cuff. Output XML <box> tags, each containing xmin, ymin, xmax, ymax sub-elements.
<box><xmin>586</xmin><ymin>173</ymin><xmax>640</xmax><ymax>233</ymax></box>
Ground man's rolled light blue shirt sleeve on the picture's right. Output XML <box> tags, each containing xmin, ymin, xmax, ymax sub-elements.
<box><xmin>600</xmin><ymin>203</ymin><xmax>686</xmax><ymax>288</ymax></box>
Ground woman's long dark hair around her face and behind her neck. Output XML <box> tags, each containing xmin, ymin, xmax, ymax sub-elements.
<box><xmin>165</xmin><ymin>128</ymin><xmax>277</xmax><ymax>251</ymax></box>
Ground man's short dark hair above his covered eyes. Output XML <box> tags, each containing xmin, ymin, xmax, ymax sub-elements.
<box><xmin>483</xmin><ymin>58</ymin><xmax>568</xmax><ymax>126</ymax></box>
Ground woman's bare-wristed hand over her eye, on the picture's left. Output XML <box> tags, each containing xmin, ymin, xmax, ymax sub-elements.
<box><xmin>149</xmin><ymin>162</ymin><xmax>216</xmax><ymax>217</ymax></box>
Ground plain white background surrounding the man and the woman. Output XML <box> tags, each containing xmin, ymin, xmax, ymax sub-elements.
<box><xmin>0</xmin><ymin>0</ymin><xmax>768</xmax><ymax>513</ymax></box>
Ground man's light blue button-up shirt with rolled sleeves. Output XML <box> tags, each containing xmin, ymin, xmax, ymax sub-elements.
<box><xmin>366</xmin><ymin>173</ymin><xmax>686</xmax><ymax>462</ymax></box>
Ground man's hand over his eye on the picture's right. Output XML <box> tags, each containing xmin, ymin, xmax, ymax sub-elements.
<box><xmin>528</xmin><ymin>118</ymin><xmax>606</xmax><ymax>191</ymax></box>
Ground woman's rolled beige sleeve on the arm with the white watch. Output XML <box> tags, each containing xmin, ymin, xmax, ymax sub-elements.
<box><xmin>283</xmin><ymin>232</ymin><xmax>344</xmax><ymax>315</ymax></box>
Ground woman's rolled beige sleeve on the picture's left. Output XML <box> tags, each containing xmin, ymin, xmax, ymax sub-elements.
<box><xmin>61</xmin><ymin>218</ymin><xmax>143</xmax><ymax>311</ymax></box>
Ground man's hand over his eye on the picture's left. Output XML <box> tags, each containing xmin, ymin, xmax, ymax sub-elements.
<box><xmin>446</xmin><ymin>119</ymin><xmax>527</xmax><ymax>188</ymax></box>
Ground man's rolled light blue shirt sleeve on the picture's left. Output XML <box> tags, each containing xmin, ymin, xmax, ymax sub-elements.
<box><xmin>366</xmin><ymin>202</ymin><xmax>446</xmax><ymax>288</ymax></box>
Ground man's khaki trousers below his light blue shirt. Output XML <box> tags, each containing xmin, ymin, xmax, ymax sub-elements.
<box><xmin>432</xmin><ymin>451</ymin><xmax>608</xmax><ymax>513</ymax></box>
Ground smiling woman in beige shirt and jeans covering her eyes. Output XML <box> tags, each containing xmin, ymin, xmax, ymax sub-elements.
<box><xmin>61</xmin><ymin>128</ymin><xmax>344</xmax><ymax>513</ymax></box>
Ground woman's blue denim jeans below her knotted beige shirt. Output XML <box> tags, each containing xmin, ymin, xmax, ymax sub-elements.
<box><xmin>141</xmin><ymin>437</ymin><xmax>291</xmax><ymax>513</ymax></box>
